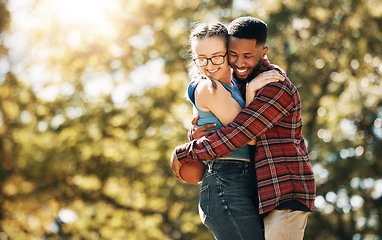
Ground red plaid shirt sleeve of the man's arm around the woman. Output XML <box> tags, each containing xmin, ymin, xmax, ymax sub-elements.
<box><xmin>175</xmin><ymin>80</ymin><xmax>297</xmax><ymax>164</ymax></box>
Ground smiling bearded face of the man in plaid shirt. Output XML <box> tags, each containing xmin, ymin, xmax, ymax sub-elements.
<box><xmin>228</xmin><ymin>37</ymin><xmax>268</xmax><ymax>81</ymax></box>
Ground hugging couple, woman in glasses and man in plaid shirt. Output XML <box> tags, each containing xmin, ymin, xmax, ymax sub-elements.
<box><xmin>171</xmin><ymin>17</ymin><xmax>316</xmax><ymax>240</ymax></box>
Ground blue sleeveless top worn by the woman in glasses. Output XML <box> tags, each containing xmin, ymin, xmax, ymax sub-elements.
<box><xmin>187</xmin><ymin>79</ymin><xmax>250</xmax><ymax>160</ymax></box>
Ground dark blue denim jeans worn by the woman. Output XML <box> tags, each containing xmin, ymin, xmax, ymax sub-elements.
<box><xmin>199</xmin><ymin>160</ymin><xmax>264</xmax><ymax>240</ymax></box>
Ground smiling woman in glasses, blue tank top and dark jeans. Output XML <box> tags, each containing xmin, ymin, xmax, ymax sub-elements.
<box><xmin>188</xmin><ymin>22</ymin><xmax>283</xmax><ymax>240</ymax></box>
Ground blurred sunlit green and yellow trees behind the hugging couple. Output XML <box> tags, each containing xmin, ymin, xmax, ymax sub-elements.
<box><xmin>0</xmin><ymin>0</ymin><xmax>382</xmax><ymax>240</ymax></box>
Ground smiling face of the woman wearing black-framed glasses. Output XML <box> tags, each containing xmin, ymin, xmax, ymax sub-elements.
<box><xmin>191</xmin><ymin>37</ymin><xmax>231</xmax><ymax>81</ymax></box>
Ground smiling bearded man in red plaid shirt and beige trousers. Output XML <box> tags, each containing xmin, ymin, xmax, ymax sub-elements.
<box><xmin>171</xmin><ymin>17</ymin><xmax>315</xmax><ymax>240</ymax></box>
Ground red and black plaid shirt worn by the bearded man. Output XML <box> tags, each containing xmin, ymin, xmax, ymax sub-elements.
<box><xmin>176</xmin><ymin>60</ymin><xmax>316</xmax><ymax>214</ymax></box>
